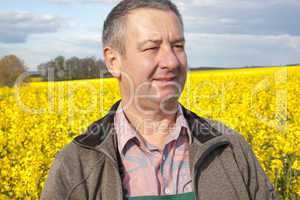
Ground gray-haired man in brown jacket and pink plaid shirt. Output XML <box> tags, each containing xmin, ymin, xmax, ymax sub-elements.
<box><xmin>42</xmin><ymin>0</ymin><xmax>275</xmax><ymax>200</ymax></box>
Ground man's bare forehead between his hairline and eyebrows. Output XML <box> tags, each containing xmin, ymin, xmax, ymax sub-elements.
<box><xmin>127</xmin><ymin>8</ymin><xmax>183</xmax><ymax>40</ymax></box>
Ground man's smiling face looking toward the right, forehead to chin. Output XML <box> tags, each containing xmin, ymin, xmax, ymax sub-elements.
<box><xmin>120</xmin><ymin>9</ymin><xmax>187</xmax><ymax>110</ymax></box>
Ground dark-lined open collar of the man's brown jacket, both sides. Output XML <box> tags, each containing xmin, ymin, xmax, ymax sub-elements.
<box><xmin>73</xmin><ymin>100</ymin><xmax>229</xmax><ymax>167</ymax></box>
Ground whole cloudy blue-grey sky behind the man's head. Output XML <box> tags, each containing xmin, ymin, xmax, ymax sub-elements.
<box><xmin>0</xmin><ymin>0</ymin><xmax>300</xmax><ymax>69</ymax></box>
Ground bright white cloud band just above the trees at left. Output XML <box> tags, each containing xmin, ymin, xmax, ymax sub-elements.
<box><xmin>0</xmin><ymin>30</ymin><xmax>101</xmax><ymax>69</ymax></box>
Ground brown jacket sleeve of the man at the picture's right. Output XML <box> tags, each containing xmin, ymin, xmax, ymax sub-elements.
<box><xmin>236</xmin><ymin>133</ymin><xmax>276</xmax><ymax>200</ymax></box>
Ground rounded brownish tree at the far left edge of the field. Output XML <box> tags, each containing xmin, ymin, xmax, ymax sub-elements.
<box><xmin>0</xmin><ymin>55</ymin><xmax>26</xmax><ymax>86</ymax></box>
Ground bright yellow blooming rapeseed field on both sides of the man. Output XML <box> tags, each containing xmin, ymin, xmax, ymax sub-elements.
<box><xmin>0</xmin><ymin>66</ymin><xmax>300</xmax><ymax>200</ymax></box>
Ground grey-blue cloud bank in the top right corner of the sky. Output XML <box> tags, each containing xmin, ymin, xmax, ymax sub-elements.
<box><xmin>176</xmin><ymin>0</ymin><xmax>300</xmax><ymax>35</ymax></box>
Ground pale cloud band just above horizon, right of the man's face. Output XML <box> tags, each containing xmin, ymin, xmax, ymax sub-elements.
<box><xmin>186</xmin><ymin>33</ymin><xmax>300</xmax><ymax>67</ymax></box>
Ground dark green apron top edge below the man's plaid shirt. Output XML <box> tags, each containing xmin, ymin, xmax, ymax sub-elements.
<box><xmin>126</xmin><ymin>192</ymin><xmax>196</xmax><ymax>200</ymax></box>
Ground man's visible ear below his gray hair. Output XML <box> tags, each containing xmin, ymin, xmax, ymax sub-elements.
<box><xmin>103</xmin><ymin>46</ymin><xmax>122</xmax><ymax>78</ymax></box>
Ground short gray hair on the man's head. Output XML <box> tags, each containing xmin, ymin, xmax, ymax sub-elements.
<box><xmin>102</xmin><ymin>0</ymin><xmax>183</xmax><ymax>55</ymax></box>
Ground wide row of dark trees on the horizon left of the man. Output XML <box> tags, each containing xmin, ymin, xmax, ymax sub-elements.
<box><xmin>38</xmin><ymin>56</ymin><xmax>111</xmax><ymax>81</ymax></box>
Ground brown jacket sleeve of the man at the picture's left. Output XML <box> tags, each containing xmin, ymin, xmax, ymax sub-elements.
<box><xmin>41</xmin><ymin>152</ymin><xmax>69</xmax><ymax>200</ymax></box>
